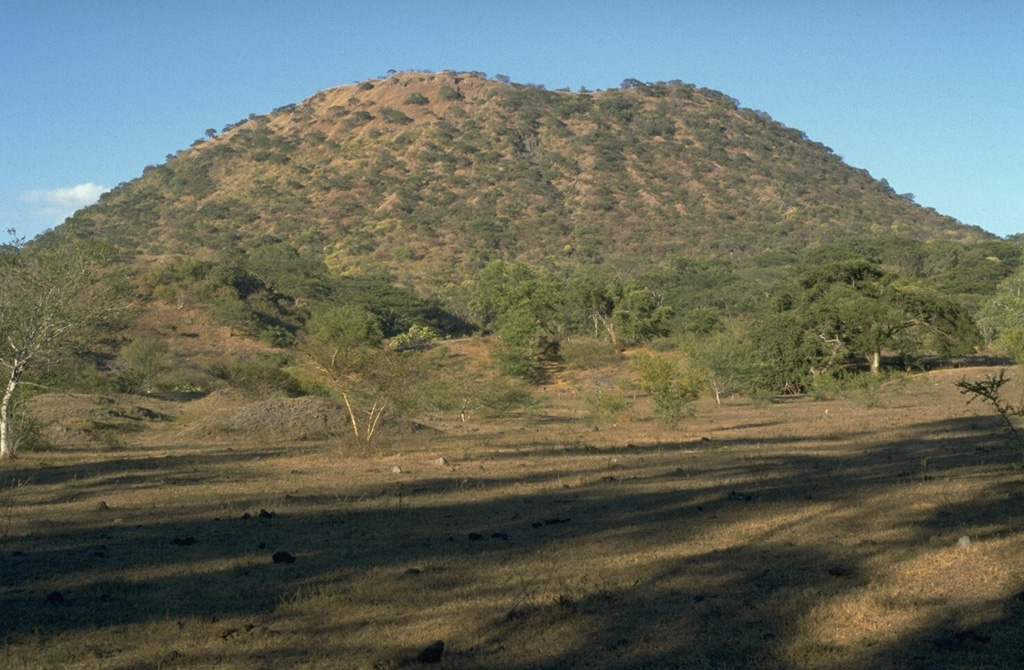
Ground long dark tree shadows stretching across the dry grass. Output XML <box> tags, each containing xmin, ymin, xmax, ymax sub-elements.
<box><xmin>0</xmin><ymin>411</ymin><xmax>1024</xmax><ymax>669</ymax></box>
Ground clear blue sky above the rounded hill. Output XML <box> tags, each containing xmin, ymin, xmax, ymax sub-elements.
<box><xmin>0</xmin><ymin>0</ymin><xmax>1024</xmax><ymax>238</ymax></box>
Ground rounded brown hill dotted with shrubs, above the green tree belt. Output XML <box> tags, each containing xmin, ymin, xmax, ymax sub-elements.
<box><xmin>76</xmin><ymin>73</ymin><xmax>993</xmax><ymax>290</ymax></box>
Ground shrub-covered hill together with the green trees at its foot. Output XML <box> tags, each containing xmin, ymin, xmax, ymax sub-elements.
<box><xmin>5</xmin><ymin>72</ymin><xmax>1024</xmax><ymax>443</ymax></box>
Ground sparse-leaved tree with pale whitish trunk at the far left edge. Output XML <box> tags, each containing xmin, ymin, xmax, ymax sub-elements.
<box><xmin>0</xmin><ymin>231</ymin><xmax>126</xmax><ymax>458</ymax></box>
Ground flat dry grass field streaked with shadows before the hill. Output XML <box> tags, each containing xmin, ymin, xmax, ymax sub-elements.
<box><xmin>0</xmin><ymin>368</ymin><xmax>1024</xmax><ymax>670</ymax></box>
